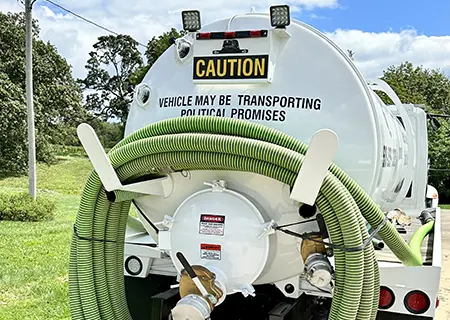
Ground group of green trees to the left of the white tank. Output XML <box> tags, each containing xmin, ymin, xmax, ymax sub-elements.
<box><xmin>0</xmin><ymin>12</ymin><xmax>184</xmax><ymax>176</ymax></box>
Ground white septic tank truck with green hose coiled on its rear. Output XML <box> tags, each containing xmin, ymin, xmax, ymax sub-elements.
<box><xmin>69</xmin><ymin>5</ymin><xmax>441</xmax><ymax>320</ymax></box>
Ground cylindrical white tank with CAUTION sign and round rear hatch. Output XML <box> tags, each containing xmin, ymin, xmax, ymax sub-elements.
<box><xmin>120</xmin><ymin>13</ymin><xmax>422</xmax><ymax>304</ymax></box>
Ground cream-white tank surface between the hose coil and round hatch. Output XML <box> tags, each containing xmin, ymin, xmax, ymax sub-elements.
<box><xmin>128</xmin><ymin>171</ymin><xmax>319</xmax><ymax>284</ymax></box>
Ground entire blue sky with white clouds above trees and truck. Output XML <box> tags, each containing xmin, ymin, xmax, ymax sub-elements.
<box><xmin>0</xmin><ymin>0</ymin><xmax>450</xmax><ymax>78</ymax></box>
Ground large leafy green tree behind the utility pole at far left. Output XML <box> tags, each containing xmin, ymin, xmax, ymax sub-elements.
<box><xmin>0</xmin><ymin>13</ymin><xmax>87</xmax><ymax>173</ymax></box>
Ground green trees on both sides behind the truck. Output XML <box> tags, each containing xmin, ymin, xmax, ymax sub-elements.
<box><xmin>0</xmin><ymin>12</ymin><xmax>450</xmax><ymax>200</ymax></box>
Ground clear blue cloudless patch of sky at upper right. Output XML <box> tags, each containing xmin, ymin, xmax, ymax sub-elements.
<box><xmin>299</xmin><ymin>0</ymin><xmax>450</xmax><ymax>36</ymax></box>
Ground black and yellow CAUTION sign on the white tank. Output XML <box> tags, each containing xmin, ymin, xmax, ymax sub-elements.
<box><xmin>193</xmin><ymin>55</ymin><xmax>269</xmax><ymax>80</ymax></box>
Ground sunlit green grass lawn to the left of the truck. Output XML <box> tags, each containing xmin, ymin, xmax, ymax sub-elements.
<box><xmin>0</xmin><ymin>157</ymin><xmax>92</xmax><ymax>320</ymax></box>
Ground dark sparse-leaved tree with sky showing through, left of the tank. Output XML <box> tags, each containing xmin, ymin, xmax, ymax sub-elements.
<box><xmin>81</xmin><ymin>35</ymin><xmax>143</xmax><ymax>123</ymax></box>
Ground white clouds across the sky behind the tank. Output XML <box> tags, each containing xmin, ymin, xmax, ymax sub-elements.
<box><xmin>0</xmin><ymin>0</ymin><xmax>450</xmax><ymax>81</ymax></box>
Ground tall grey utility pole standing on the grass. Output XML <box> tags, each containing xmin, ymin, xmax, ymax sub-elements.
<box><xmin>25</xmin><ymin>0</ymin><xmax>36</xmax><ymax>199</ymax></box>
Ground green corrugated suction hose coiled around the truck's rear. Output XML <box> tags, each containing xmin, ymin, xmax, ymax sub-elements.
<box><xmin>69</xmin><ymin>117</ymin><xmax>422</xmax><ymax>320</ymax></box>
